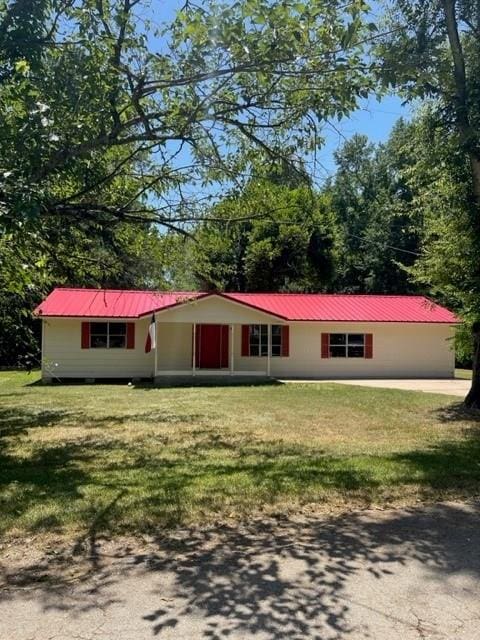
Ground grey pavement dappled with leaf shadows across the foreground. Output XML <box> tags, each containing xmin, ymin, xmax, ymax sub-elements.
<box><xmin>0</xmin><ymin>503</ymin><xmax>480</xmax><ymax>640</ymax></box>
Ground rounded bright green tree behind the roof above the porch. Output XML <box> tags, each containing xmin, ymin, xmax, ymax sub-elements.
<box><xmin>177</xmin><ymin>174</ymin><xmax>336</xmax><ymax>291</ymax></box>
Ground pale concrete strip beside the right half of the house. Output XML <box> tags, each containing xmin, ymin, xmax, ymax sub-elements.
<box><xmin>280</xmin><ymin>378</ymin><xmax>470</xmax><ymax>397</ymax></box>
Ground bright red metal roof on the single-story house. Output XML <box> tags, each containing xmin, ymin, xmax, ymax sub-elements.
<box><xmin>34</xmin><ymin>288</ymin><xmax>459</xmax><ymax>324</ymax></box>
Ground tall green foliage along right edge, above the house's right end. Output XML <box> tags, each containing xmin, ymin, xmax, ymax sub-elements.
<box><xmin>377</xmin><ymin>0</ymin><xmax>480</xmax><ymax>304</ymax></box>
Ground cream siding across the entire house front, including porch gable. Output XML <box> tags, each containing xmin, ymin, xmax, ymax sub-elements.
<box><xmin>43</xmin><ymin>298</ymin><xmax>454</xmax><ymax>378</ymax></box>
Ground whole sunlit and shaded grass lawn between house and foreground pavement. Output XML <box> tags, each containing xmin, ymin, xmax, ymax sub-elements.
<box><xmin>0</xmin><ymin>373</ymin><xmax>480</xmax><ymax>536</ymax></box>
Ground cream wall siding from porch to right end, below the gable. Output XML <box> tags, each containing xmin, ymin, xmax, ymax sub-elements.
<box><xmin>154</xmin><ymin>320</ymin><xmax>454</xmax><ymax>378</ymax></box>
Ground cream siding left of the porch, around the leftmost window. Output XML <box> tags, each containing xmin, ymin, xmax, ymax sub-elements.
<box><xmin>42</xmin><ymin>318</ymin><xmax>154</xmax><ymax>378</ymax></box>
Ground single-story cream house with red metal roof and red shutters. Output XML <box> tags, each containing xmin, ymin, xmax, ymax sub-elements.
<box><xmin>35</xmin><ymin>288</ymin><xmax>459</xmax><ymax>380</ymax></box>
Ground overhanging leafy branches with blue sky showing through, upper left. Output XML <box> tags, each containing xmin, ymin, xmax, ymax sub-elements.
<box><xmin>0</xmin><ymin>0</ymin><xmax>375</xmax><ymax>229</ymax></box>
